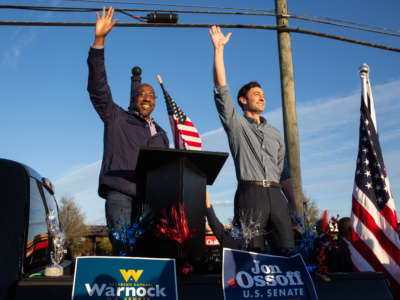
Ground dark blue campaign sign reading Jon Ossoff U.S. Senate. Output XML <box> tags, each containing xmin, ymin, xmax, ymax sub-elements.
<box><xmin>222</xmin><ymin>248</ymin><xmax>318</xmax><ymax>300</ymax></box>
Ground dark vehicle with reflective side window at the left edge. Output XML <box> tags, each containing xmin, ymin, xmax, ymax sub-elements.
<box><xmin>0</xmin><ymin>159</ymin><xmax>65</xmax><ymax>299</ymax></box>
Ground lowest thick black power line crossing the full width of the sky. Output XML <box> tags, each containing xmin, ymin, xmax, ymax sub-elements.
<box><xmin>0</xmin><ymin>21</ymin><xmax>400</xmax><ymax>52</ymax></box>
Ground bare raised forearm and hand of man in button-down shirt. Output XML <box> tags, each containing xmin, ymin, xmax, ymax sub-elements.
<box><xmin>210</xmin><ymin>25</ymin><xmax>232</xmax><ymax>87</ymax></box>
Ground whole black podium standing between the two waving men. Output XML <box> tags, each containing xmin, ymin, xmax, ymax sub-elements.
<box><xmin>136</xmin><ymin>147</ymin><xmax>228</xmax><ymax>265</ymax></box>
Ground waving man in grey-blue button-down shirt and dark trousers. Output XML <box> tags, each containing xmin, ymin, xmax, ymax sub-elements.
<box><xmin>210</xmin><ymin>26</ymin><xmax>296</xmax><ymax>253</ymax></box>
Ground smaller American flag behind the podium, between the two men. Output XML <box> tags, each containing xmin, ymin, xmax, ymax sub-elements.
<box><xmin>157</xmin><ymin>76</ymin><xmax>201</xmax><ymax>151</ymax></box>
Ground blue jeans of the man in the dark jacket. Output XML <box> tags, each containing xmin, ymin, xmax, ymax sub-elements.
<box><xmin>105</xmin><ymin>190</ymin><xmax>142</xmax><ymax>256</ymax></box>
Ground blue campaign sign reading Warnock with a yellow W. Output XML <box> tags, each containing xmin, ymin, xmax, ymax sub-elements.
<box><xmin>72</xmin><ymin>256</ymin><xmax>178</xmax><ymax>300</ymax></box>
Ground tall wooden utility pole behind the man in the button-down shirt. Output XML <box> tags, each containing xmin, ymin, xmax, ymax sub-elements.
<box><xmin>275</xmin><ymin>0</ymin><xmax>303</xmax><ymax>216</ymax></box>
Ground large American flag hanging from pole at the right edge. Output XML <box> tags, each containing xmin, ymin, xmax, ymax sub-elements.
<box><xmin>349</xmin><ymin>64</ymin><xmax>400</xmax><ymax>299</ymax></box>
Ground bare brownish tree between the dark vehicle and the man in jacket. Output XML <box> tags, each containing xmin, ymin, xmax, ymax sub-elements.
<box><xmin>58</xmin><ymin>196</ymin><xmax>90</xmax><ymax>257</ymax></box>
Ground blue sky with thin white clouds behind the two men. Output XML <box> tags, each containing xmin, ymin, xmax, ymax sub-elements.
<box><xmin>0</xmin><ymin>0</ymin><xmax>400</xmax><ymax>224</ymax></box>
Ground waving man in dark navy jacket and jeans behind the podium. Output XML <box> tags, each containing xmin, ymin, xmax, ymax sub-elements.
<box><xmin>88</xmin><ymin>7</ymin><xmax>169</xmax><ymax>255</ymax></box>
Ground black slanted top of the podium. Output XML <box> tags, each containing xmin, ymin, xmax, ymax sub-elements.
<box><xmin>136</xmin><ymin>147</ymin><xmax>229</xmax><ymax>185</ymax></box>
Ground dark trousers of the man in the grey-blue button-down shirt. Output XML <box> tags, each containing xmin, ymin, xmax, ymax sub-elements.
<box><xmin>233</xmin><ymin>184</ymin><xmax>294</xmax><ymax>254</ymax></box>
